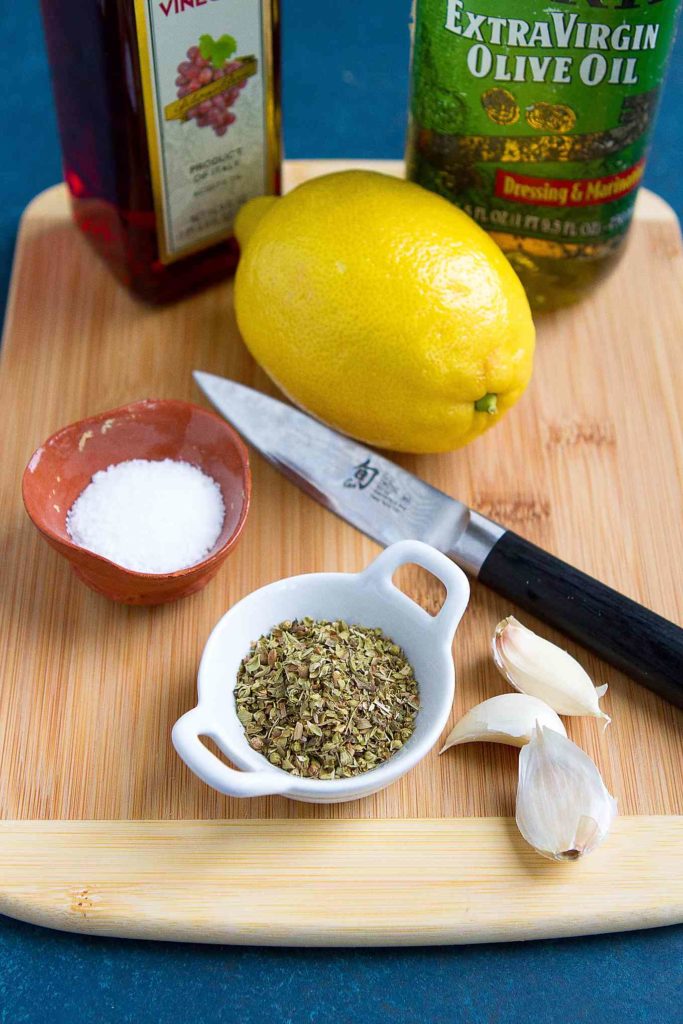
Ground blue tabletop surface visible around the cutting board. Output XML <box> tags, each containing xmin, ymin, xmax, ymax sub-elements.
<box><xmin>0</xmin><ymin>0</ymin><xmax>683</xmax><ymax>1024</ymax></box>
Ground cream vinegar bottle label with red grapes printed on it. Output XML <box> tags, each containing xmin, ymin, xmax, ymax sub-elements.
<box><xmin>135</xmin><ymin>0</ymin><xmax>274</xmax><ymax>263</ymax></box>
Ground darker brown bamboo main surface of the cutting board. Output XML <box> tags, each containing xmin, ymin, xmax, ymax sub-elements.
<box><xmin>0</xmin><ymin>163</ymin><xmax>683</xmax><ymax>831</ymax></box>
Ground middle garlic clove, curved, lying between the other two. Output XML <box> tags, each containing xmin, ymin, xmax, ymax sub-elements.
<box><xmin>439</xmin><ymin>693</ymin><xmax>566</xmax><ymax>754</ymax></box>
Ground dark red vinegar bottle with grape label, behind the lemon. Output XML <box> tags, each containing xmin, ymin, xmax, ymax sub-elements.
<box><xmin>42</xmin><ymin>0</ymin><xmax>281</xmax><ymax>302</ymax></box>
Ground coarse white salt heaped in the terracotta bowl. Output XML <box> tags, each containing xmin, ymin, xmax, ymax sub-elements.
<box><xmin>67</xmin><ymin>459</ymin><xmax>225</xmax><ymax>572</ymax></box>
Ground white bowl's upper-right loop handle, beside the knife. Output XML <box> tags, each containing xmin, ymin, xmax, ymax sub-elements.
<box><xmin>360</xmin><ymin>541</ymin><xmax>470</xmax><ymax>644</ymax></box>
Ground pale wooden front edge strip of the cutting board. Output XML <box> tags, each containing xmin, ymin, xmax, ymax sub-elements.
<box><xmin>0</xmin><ymin>816</ymin><xmax>683</xmax><ymax>946</ymax></box>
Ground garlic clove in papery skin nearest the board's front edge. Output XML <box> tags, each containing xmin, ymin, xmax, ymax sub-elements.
<box><xmin>516</xmin><ymin>726</ymin><xmax>616</xmax><ymax>860</ymax></box>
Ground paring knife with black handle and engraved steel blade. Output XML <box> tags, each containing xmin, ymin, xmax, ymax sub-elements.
<box><xmin>194</xmin><ymin>372</ymin><xmax>683</xmax><ymax>708</ymax></box>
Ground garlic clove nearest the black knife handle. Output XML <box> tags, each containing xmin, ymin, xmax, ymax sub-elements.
<box><xmin>492</xmin><ymin>615</ymin><xmax>611</xmax><ymax>727</ymax></box>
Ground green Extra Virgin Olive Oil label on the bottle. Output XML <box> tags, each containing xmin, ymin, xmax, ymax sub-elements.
<box><xmin>409</xmin><ymin>0</ymin><xmax>680</xmax><ymax>252</ymax></box>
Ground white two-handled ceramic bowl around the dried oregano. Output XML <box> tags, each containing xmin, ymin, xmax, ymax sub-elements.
<box><xmin>172</xmin><ymin>541</ymin><xmax>469</xmax><ymax>804</ymax></box>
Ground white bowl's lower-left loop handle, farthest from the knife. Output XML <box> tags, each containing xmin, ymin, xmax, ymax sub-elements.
<box><xmin>171</xmin><ymin>708</ymin><xmax>290</xmax><ymax>797</ymax></box>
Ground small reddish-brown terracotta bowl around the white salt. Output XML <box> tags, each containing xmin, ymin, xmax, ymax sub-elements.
<box><xmin>22</xmin><ymin>399</ymin><xmax>251</xmax><ymax>604</ymax></box>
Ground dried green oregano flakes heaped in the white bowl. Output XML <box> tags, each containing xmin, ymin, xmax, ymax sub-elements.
<box><xmin>234</xmin><ymin>618</ymin><xmax>420</xmax><ymax>779</ymax></box>
